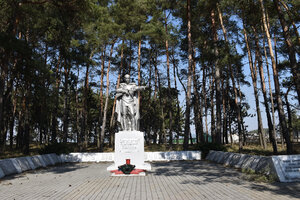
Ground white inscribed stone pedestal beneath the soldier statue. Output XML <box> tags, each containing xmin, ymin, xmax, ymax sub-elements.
<box><xmin>107</xmin><ymin>131</ymin><xmax>151</xmax><ymax>171</ymax></box>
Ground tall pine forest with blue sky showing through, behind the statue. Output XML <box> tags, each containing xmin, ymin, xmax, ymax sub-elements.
<box><xmin>0</xmin><ymin>0</ymin><xmax>300</xmax><ymax>154</ymax></box>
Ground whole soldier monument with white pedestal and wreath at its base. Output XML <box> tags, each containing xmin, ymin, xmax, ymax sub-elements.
<box><xmin>107</xmin><ymin>74</ymin><xmax>151</xmax><ymax>175</ymax></box>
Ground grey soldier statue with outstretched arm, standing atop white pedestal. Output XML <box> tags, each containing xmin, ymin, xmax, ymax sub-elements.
<box><xmin>116</xmin><ymin>74</ymin><xmax>146</xmax><ymax>131</ymax></box>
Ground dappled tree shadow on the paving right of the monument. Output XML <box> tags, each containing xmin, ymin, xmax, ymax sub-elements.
<box><xmin>148</xmin><ymin>161</ymin><xmax>300</xmax><ymax>199</ymax></box>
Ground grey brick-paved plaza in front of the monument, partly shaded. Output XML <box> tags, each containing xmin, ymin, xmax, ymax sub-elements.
<box><xmin>0</xmin><ymin>161</ymin><xmax>300</xmax><ymax>200</ymax></box>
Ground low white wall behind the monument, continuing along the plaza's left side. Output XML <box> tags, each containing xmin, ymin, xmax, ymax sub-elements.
<box><xmin>0</xmin><ymin>151</ymin><xmax>201</xmax><ymax>178</ymax></box>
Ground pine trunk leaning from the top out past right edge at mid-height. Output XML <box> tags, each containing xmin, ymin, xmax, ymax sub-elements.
<box><xmin>274</xmin><ymin>0</ymin><xmax>300</xmax><ymax>104</ymax></box>
